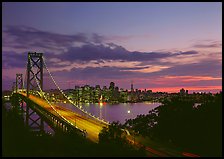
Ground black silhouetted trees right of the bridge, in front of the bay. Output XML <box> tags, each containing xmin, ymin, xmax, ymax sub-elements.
<box><xmin>125</xmin><ymin>92</ymin><xmax>222</xmax><ymax>157</ymax></box>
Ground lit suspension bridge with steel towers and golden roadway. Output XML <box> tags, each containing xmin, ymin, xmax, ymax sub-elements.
<box><xmin>10</xmin><ymin>52</ymin><xmax>109</xmax><ymax>142</ymax></box>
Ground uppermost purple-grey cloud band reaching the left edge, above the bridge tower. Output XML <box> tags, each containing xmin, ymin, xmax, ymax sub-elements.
<box><xmin>3</xmin><ymin>26</ymin><xmax>98</xmax><ymax>51</ymax></box>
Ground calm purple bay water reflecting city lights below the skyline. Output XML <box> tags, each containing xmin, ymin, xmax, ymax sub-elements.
<box><xmin>58</xmin><ymin>102</ymin><xmax>161</xmax><ymax>124</ymax></box>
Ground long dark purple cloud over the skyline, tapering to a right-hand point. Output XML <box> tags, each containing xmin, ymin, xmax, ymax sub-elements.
<box><xmin>57</xmin><ymin>44</ymin><xmax>175</xmax><ymax>61</ymax></box>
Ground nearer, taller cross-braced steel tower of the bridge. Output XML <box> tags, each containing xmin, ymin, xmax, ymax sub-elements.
<box><xmin>26</xmin><ymin>52</ymin><xmax>44</xmax><ymax>132</ymax></box>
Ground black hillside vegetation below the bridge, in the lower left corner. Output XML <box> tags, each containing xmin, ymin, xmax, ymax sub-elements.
<box><xmin>2</xmin><ymin>98</ymin><xmax>145</xmax><ymax>157</ymax></box>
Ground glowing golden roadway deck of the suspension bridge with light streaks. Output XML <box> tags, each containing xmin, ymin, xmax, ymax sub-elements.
<box><xmin>19</xmin><ymin>92</ymin><xmax>106</xmax><ymax>142</ymax></box>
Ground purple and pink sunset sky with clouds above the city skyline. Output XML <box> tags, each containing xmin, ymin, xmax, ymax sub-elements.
<box><xmin>2</xmin><ymin>2</ymin><xmax>222</xmax><ymax>93</ymax></box>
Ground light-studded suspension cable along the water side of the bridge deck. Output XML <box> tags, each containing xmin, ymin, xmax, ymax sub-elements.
<box><xmin>43</xmin><ymin>58</ymin><xmax>109</xmax><ymax>124</ymax></box>
